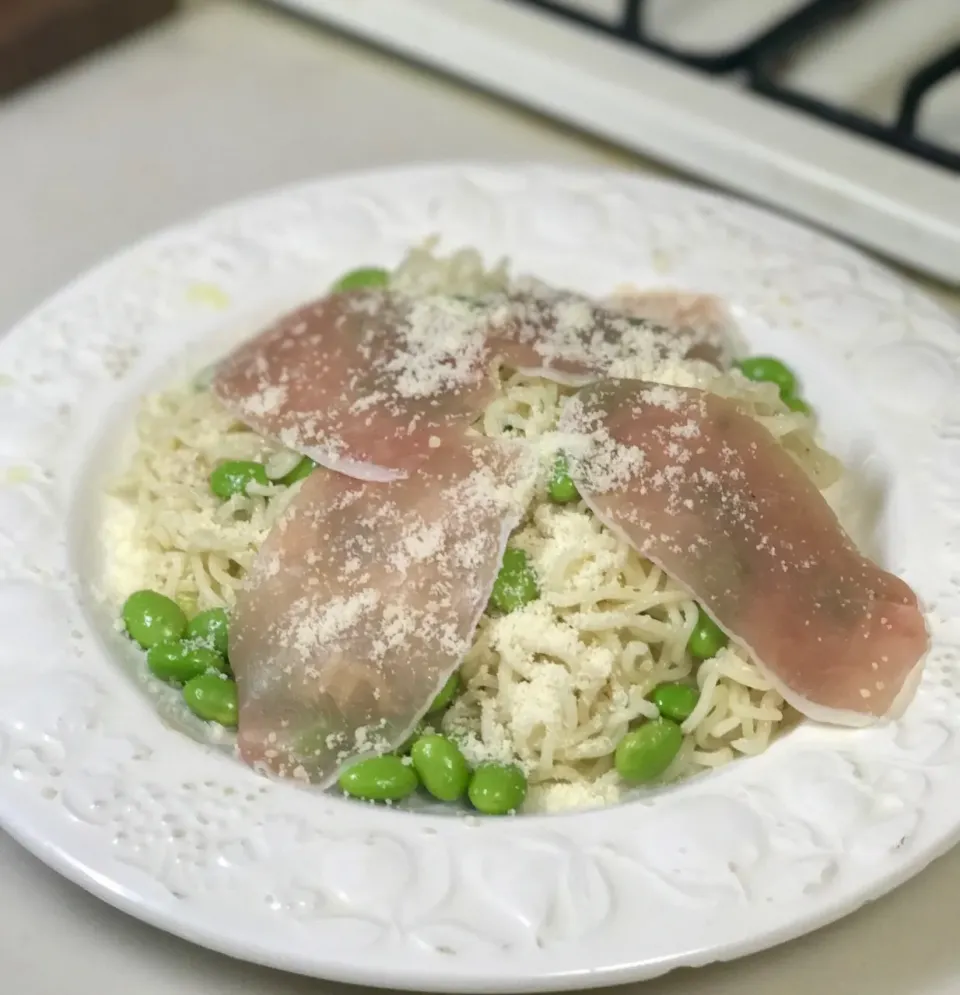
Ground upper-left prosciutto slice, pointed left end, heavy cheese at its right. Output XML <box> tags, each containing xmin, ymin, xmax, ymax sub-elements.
<box><xmin>212</xmin><ymin>291</ymin><xmax>492</xmax><ymax>480</ymax></box>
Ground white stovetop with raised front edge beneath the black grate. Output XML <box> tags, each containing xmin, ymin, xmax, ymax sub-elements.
<box><xmin>269</xmin><ymin>0</ymin><xmax>960</xmax><ymax>286</ymax></box>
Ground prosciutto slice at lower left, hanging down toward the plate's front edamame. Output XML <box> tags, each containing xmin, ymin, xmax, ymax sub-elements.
<box><xmin>230</xmin><ymin>436</ymin><xmax>537</xmax><ymax>785</ymax></box>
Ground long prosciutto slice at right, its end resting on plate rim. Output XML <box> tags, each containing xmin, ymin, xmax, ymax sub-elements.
<box><xmin>560</xmin><ymin>380</ymin><xmax>928</xmax><ymax>725</ymax></box>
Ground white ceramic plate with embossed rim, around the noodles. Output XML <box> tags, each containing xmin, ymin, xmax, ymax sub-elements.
<box><xmin>0</xmin><ymin>166</ymin><xmax>960</xmax><ymax>992</ymax></box>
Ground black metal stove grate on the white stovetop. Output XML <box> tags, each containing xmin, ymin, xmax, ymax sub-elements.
<box><xmin>512</xmin><ymin>0</ymin><xmax>960</xmax><ymax>173</ymax></box>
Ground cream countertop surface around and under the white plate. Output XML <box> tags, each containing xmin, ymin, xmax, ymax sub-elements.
<box><xmin>0</xmin><ymin>2</ymin><xmax>960</xmax><ymax>995</ymax></box>
